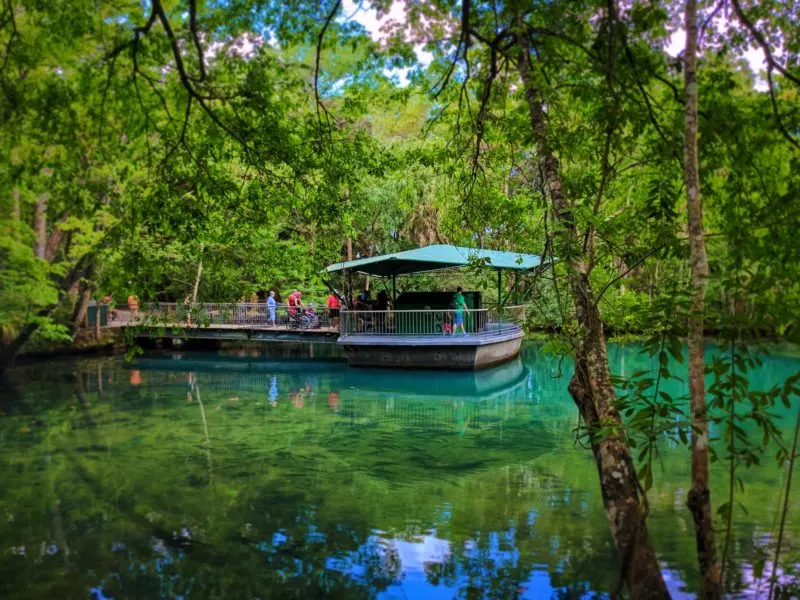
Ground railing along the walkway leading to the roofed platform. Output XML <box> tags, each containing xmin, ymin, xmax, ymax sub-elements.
<box><xmin>114</xmin><ymin>302</ymin><xmax>338</xmax><ymax>329</ymax></box>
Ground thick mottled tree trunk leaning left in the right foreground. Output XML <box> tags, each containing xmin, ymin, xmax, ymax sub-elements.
<box><xmin>515</xmin><ymin>22</ymin><xmax>670</xmax><ymax>599</ymax></box>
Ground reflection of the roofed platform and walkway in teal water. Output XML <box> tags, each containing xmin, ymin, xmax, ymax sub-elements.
<box><xmin>128</xmin><ymin>354</ymin><xmax>534</xmax><ymax>431</ymax></box>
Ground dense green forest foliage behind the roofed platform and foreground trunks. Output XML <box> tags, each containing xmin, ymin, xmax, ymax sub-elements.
<box><xmin>0</xmin><ymin>3</ymin><xmax>800</xmax><ymax>339</ymax></box>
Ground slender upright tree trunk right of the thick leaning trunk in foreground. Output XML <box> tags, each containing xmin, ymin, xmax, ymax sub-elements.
<box><xmin>683</xmin><ymin>0</ymin><xmax>722</xmax><ymax>599</ymax></box>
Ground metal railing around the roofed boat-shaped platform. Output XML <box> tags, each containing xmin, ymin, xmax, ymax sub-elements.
<box><xmin>340</xmin><ymin>306</ymin><xmax>525</xmax><ymax>339</ymax></box>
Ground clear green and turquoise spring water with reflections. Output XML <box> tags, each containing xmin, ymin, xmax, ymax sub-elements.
<box><xmin>0</xmin><ymin>345</ymin><xmax>800</xmax><ymax>599</ymax></box>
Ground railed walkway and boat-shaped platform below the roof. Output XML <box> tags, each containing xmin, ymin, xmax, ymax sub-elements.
<box><xmin>109</xmin><ymin>303</ymin><xmax>524</xmax><ymax>358</ymax></box>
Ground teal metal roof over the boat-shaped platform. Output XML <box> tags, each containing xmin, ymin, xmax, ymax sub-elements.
<box><xmin>325</xmin><ymin>244</ymin><xmax>541</xmax><ymax>277</ymax></box>
